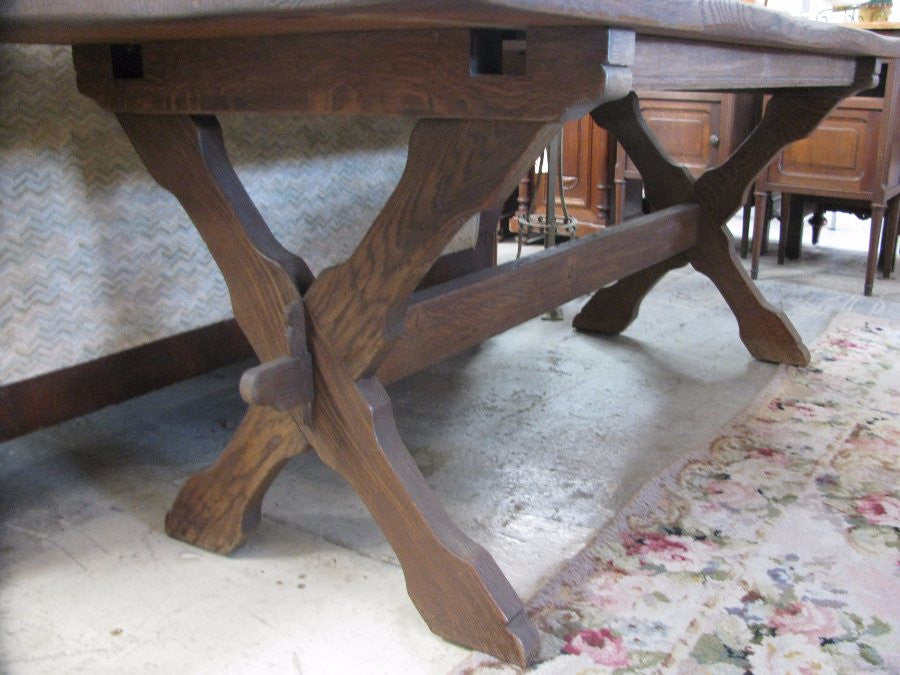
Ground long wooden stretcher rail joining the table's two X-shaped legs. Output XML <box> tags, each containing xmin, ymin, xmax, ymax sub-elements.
<box><xmin>378</xmin><ymin>204</ymin><xmax>700</xmax><ymax>383</ymax></box>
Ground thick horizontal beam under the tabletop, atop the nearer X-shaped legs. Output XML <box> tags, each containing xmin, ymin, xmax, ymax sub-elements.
<box><xmin>73</xmin><ymin>27</ymin><xmax>634</xmax><ymax>122</ymax></box>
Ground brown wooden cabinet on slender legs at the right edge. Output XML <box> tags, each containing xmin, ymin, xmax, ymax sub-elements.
<box><xmin>751</xmin><ymin>30</ymin><xmax>900</xmax><ymax>295</ymax></box>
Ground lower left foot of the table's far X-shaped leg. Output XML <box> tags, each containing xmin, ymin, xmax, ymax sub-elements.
<box><xmin>572</xmin><ymin>257</ymin><xmax>687</xmax><ymax>336</ymax></box>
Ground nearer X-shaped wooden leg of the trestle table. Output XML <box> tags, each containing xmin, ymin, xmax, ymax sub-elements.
<box><xmin>119</xmin><ymin>114</ymin><xmax>559</xmax><ymax>665</ymax></box>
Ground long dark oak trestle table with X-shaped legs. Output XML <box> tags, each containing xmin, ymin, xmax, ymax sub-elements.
<box><xmin>0</xmin><ymin>0</ymin><xmax>900</xmax><ymax>664</ymax></box>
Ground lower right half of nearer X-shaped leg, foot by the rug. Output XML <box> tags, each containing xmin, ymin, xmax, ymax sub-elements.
<box><xmin>304</xmin><ymin>332</ymin><xmax>540</xmax><ymax>666</ymax></box>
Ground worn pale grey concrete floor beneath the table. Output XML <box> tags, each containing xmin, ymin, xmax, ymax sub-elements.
<box><xmin>0</xmin><ymin>217</ymin><xmax>900</xmax><ymax>674</ymax></box>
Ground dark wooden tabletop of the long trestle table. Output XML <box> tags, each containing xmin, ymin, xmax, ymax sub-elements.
<box><xmin>0</xmin><ymin>0</ymin><xmax>900</xmax><ymax>57</ymax></box>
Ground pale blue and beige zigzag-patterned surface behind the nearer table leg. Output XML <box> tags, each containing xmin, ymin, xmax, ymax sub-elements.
<box><xmin>0</xmin><ymin>45</ymin><xmax>475</xmax><ymax>385</ymax></box>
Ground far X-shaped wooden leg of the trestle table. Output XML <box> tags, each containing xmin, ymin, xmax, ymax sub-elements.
<box><xmin>574</xmin><ymin>89</ymin><xmax>864</xmax><ymax>365</ymax></box>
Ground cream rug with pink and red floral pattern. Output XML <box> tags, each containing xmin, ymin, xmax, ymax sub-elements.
<box><xmin>454</xmin><ymin>314</ymin><xmax>900</xmax><ymax>675</ymax></box>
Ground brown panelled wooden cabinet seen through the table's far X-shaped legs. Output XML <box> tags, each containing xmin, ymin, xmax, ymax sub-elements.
<box><xmin>613</xmin><ymin>92</ymin><xmax>759</xmax><ymax>223</ymax></box>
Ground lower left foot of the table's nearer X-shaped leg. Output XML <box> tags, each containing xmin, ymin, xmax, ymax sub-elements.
<box><xmin>166</xmin><ymin>406</ymin><xmax>309</xmax><ymax>553</ymax></box>
